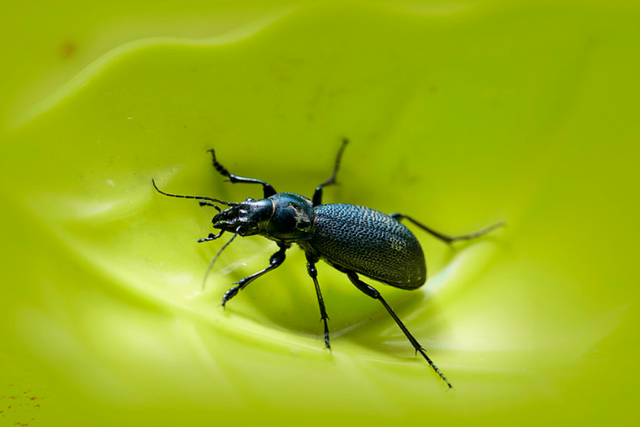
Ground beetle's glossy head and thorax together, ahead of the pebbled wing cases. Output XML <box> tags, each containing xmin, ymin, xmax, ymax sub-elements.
<box><xmin>212</xmin><ymin>193</ymin><xmax>315</xmax><ymax>241</ymax></box>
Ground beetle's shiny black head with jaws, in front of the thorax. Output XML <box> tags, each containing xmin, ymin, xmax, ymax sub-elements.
<box><xmin>211</xmin><ymin>198</ymin><xmax>274</xmax><ymax>237</ymax></box>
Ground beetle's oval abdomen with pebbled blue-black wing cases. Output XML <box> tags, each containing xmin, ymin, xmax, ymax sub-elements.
<box><xmin>309</xmin><ymin>203</ymin><xmax>427</xmax><ymax>289</ymax></box>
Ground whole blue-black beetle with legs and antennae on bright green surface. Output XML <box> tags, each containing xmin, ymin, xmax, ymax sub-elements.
<box><xmin>152</xmin><ymin>139</ymin><xmax>504</xmax><ymax>388</ymax></box>
